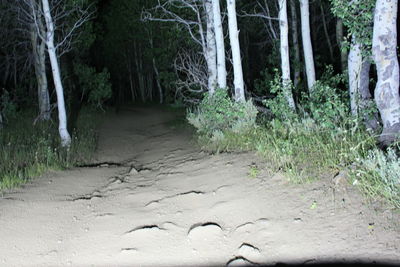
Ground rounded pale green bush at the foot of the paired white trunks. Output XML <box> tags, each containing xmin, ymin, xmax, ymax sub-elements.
<box><xmin>187</xmin><ymin>89</ymin><xmax>258</xmax><ymax>138</ymax></box>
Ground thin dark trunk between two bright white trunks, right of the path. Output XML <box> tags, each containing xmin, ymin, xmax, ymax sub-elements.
<box><xmin>290</xmin><ymin>0</ymin><xmax>301</xmax><ymax>87</ymax></box>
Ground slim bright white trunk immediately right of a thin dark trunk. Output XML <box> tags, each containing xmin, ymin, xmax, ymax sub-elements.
<box><xmin>300</xmin><ymin>0</ymin><xmax>315</xmax><ymax>93</ymax></box>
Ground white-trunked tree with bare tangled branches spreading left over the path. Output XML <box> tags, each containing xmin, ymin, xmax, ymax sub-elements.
<box><xmin>142</xmin><ymin>0</ymin><xmax>217</xmax><ymax>95</ymax></box>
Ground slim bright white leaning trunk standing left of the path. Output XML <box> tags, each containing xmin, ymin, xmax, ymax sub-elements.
<box><xmin>42</xmin><ymin>0</ymin><xmax>71</xmax><ymax>147</ymax></box>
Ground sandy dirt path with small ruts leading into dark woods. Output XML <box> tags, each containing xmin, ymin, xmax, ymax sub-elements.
<box><xmin>0</xmin><ymin>108</ymin><xmax>400</xmax><ymax>267</ymax></box>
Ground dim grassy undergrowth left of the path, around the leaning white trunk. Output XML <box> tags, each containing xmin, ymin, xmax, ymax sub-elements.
<box><xmin>0</xmin><ymin>109</ymin><xmax>98</xmax><ymax>190</ymax></box>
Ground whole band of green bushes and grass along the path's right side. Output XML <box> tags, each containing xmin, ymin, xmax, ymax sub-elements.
<box><xmin>187</xmin><ymin>69</ymin><xmax>400</xmax><ymax>208</ymax></box>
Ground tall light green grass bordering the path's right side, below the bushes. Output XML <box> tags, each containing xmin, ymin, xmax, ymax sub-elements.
<box><xmin>199</xmin><ymin>120</ymin><xmax>374</xmax><ymax>183</ymax></box>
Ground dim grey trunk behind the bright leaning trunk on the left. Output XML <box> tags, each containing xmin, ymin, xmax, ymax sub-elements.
<box><xmin>31</xmin><ymin>21</ymin><xmax>50</xmax><ymax>120</ymax></box>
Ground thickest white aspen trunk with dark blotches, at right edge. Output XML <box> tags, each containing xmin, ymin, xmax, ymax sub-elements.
<box><xmin>372</xmin><ymin>0</ymin><xmax>400</xmax><ymax>145</ymax></box>
